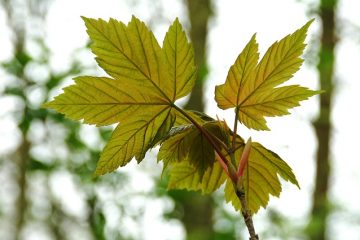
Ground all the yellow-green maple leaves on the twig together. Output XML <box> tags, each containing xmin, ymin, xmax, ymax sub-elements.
<box><xmin>44</xmin><ymin>17</ymin><xmax>319</xmax><ymax>213</ymax></box>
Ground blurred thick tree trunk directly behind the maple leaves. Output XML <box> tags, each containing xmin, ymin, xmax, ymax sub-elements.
<box><xmin>178</xmin><ymin>0</ymin><xmax>214</xmax><ymax>240</ymax></box>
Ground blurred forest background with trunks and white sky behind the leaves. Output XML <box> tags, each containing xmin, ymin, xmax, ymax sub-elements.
<box><xmin>0</xmin><ymin>0</ymin><xmax>360</xmax><ymax>240</ymax></box>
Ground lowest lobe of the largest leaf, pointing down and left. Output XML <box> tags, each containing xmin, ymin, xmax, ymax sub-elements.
<box><xmin>95</xmin><ymin>106</ymin><xmax>174</xmax><ymax>175</ymax></box>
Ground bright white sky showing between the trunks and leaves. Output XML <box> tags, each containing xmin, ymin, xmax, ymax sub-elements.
<box><xmin>0</xmin><ymin>0</ymin><xmax>360</xmax><ymax>240</ymax></box>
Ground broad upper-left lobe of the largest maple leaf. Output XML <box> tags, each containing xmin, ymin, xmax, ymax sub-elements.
<box><xmin>83</xmin><ymin>17</ymin><xmax>172</xmax><ymax>99</ymax></box>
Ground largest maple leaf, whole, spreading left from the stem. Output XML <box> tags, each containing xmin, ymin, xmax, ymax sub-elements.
<box><xmin>44</xmin><ymin>17</ymin><xmax>196</xmax><ymax>175</ymax></box>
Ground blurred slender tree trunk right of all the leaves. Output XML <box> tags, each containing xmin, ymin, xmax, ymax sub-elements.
<box><xmin>309</xmin><ymin>0</ymin><xmax>337</xmax><ymax>240</ymax></box>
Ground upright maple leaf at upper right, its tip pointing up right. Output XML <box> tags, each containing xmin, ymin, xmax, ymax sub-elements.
<box><xmin>215</xmin><ymin>20</ymin><xmax>320</xmax><ymax>130</ymax></box>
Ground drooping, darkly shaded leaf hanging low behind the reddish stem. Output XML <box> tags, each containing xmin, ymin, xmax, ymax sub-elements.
<box><xmin>158</xmin><ymin>117</ymin><xmax>231</xmax><ymax>194</ymax></box>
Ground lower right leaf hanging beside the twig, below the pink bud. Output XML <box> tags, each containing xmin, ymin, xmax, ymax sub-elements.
<box><xmin>225</xmin><ymin>142</ymin><xmax>299</xmax><ymax>213</ymax></box>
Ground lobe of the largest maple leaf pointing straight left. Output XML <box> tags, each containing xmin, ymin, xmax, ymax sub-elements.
<box><xmin>43</xmin><ymin>76</ymin><xmax>168</xmax><ymax>126</ymax></box>
